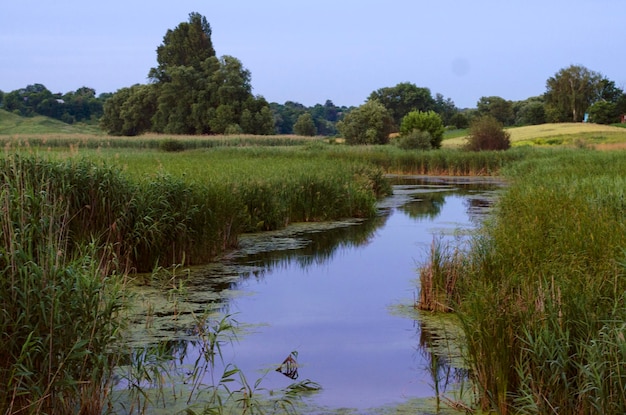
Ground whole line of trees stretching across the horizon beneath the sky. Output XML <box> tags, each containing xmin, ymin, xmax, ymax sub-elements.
<box><xmin>0</xmin><ymin>13</ymin><xmax>626</xmax><ymax>136</ymax></box>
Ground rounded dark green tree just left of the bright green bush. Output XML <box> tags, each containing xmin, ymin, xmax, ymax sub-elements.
<box><xmin>337</xmin><ymin>100</ymin><xmax>394</xmax><ymax>144</ymax></box>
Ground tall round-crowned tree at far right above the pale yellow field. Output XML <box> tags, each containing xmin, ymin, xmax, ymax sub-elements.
<box><xmin>545</xmin><ymin>65</ymin><xmax>603</xmax><ymax>122</ymax></box>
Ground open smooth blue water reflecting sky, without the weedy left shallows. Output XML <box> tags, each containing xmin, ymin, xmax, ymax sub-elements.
<box><xmin>124</xmin><ymin>180</ymin><xmax>496</xmax><ymax>410</ymax></box>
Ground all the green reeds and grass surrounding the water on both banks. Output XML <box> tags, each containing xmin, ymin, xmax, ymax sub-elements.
<box><xmin>0</xmin><ymin>122</ymin><xmax>626</xmax><ymax>414</ymax></box>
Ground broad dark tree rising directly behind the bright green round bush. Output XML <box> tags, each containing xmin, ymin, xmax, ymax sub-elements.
<box><xmin>368</xmin><ymin>82</ymin><xmax>435</xmax><ymax>128</ymax></box>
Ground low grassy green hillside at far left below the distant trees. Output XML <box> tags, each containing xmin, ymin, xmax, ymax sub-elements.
<box><xmin>0</xmin><ymin>110</ymin><xmax>103</xmax><ymax>135</ymax></box>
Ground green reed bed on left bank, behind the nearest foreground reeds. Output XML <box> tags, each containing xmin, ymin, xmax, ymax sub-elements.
<box><xmin>3</xmin><ymin>148</ymin><xmax>388</xmax><ymax>271</ymax></box>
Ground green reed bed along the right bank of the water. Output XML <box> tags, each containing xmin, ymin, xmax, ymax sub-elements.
<box><xmin>416</xmin><ymin>150</ymin><xmax>626</xmax><ymax>414</ymax></box>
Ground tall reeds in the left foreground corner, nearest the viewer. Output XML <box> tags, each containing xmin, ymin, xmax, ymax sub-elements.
<box><xmin>0</xmin><ymin>154</ymin><xmax>124</xmax><ymax>414</ymax></box>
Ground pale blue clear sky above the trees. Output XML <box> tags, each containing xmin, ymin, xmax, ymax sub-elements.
<box><xmin>0</xmin><ymin>0</ymin><xmax>626</xmax><ymax>108</ymax></box>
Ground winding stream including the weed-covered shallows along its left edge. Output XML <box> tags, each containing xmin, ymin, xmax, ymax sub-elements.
<box><xmin>120</xmin><ymin>177</ymin><xmax>502</xmax><ymax>413</ymax></box>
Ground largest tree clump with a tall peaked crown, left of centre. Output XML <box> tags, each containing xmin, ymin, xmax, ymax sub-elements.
<box><xmin>101</xmin><ymin>13</ymin><xmax>275</xmax><ymax>135</ymax></box>
